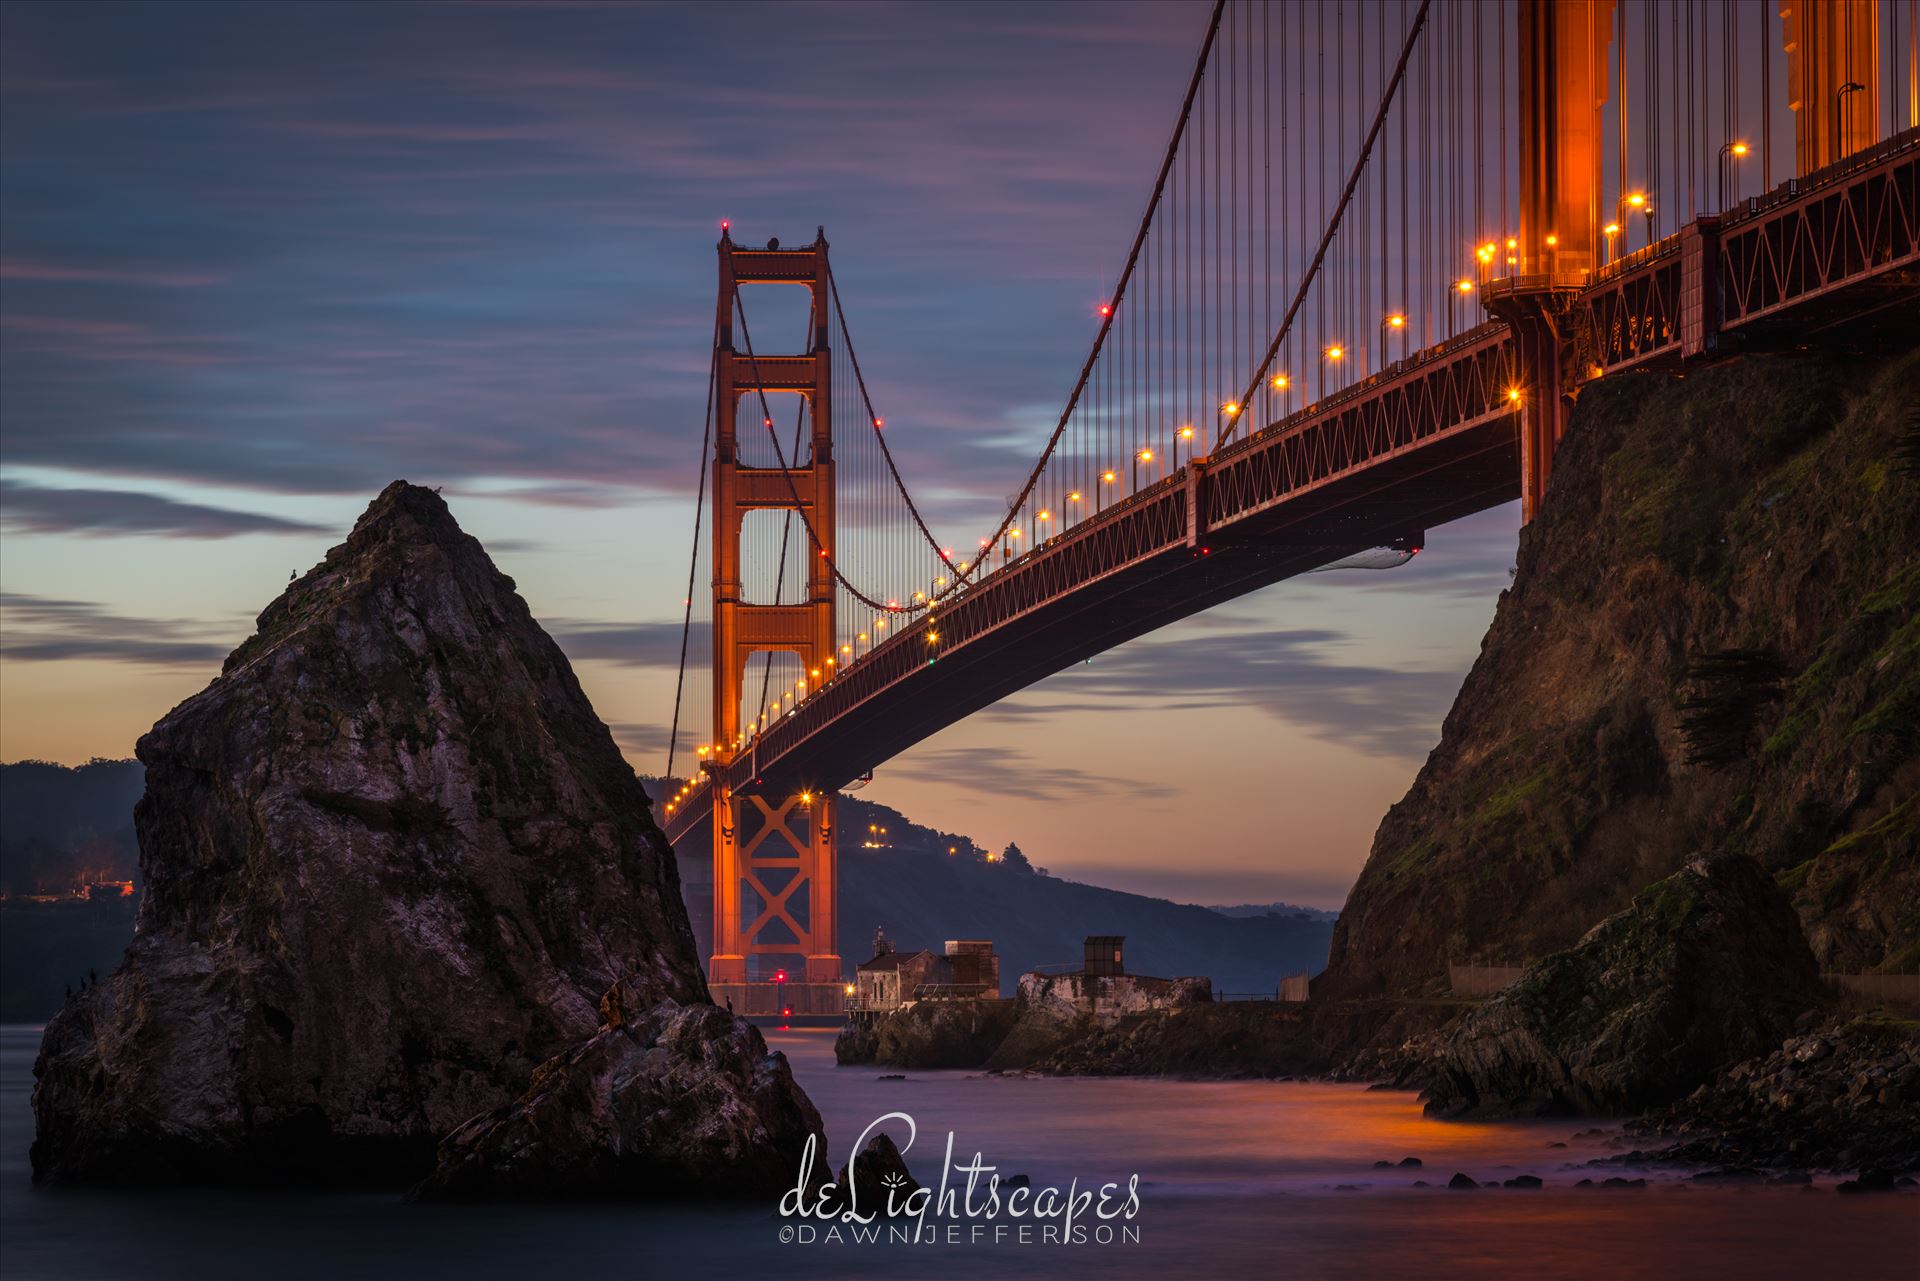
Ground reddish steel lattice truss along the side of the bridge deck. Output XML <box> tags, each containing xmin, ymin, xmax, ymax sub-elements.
<box><xmin>668</xmin><ymin>131</ymin><xmax>1920</xmax><ymax>839</ymax></box>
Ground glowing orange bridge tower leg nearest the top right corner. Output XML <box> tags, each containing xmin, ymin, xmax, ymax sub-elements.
<box><xmin>1780</xmin><ymin>0</ymin><xmax>1880</xmax><ymax>175</ymax></box>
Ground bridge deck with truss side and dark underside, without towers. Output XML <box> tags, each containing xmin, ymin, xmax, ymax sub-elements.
<box><xmin>666</xmin><ymin>131</ymin><xmax>1920</xmax><ymax>852</ymax></box>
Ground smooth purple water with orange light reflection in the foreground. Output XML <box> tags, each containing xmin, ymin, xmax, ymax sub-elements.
<box><xmin>0</xmin><ymin>1027</ymin><xmax>1920</xmax><ymax>1281</ymax></box>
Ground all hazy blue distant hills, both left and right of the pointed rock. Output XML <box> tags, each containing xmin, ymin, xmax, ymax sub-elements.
<box><xmin>0</xmin><ymin>761</ymin><xmax>1332</xmax><ymax>1020</ymax></box>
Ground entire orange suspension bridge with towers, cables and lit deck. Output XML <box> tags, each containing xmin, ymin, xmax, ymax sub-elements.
<box><xmin>660</xmin><ymin>0</ymin><xmax>1920</xmax><ymax>1012</ymax></box>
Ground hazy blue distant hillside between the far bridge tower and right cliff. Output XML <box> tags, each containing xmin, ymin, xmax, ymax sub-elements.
<box><xmin>649</xmin><ymin>782</ymin><xmax>1332</xmax><ymax>993</ymax></box>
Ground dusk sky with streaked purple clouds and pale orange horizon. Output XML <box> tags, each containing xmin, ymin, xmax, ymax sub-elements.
<box><xmin>0</xmin><ymin>4</ymin><xmax>1519</xmax><ymax>906</ymax></box>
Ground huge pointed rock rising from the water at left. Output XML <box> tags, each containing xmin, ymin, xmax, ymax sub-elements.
<box><xmin>33</xmin><ymin>482</ymin><xmax>714</xmax><ymax>1181</ymax></box>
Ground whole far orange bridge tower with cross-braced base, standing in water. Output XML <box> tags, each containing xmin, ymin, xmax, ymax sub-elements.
<box><xmin>703</xmin><ymin>232</ymin><xmax>843</xmax><ymax>1014</ymax></box>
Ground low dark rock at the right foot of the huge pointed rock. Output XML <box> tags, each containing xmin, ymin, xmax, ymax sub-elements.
<box><xmin>417</xmin><ymin>987</ymin><xmax>826</xmax><ymax>1206</ymax></box>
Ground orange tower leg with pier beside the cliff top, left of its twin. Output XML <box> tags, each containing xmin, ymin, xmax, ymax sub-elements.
<box><xmin>1486</xmin><ymin>0</ymin><xmax>1615</xmax><ymax>520</ymax></box>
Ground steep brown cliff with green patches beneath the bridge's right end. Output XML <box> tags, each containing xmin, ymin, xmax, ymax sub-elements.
<box><xmin>1315</xmin><ymin>350</ymin><xmax>1920</xmax><ymax>997</ymax></box>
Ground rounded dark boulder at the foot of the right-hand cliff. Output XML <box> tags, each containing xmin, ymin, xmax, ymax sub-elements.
<box><xmin>1428</xmin><ymin>855</ymin><xmax>1822</xmax><ymax>1114</ymax></box>
